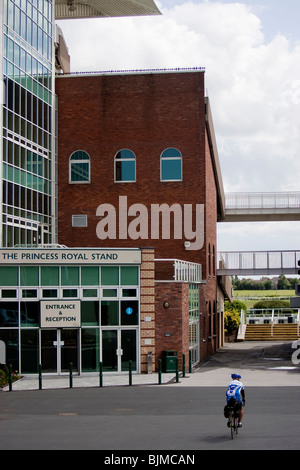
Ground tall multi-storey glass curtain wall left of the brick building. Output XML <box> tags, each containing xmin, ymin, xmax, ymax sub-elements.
<box><xmin>0</xmin><ymin>0</ymin><xmax>55</xmax><ymax>247</ymax></box>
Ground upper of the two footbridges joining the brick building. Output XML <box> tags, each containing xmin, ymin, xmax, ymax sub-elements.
<box><xmin>220</xmin><ymin>192</ymin><xmax>300</xmax><ymax>222</ymax></box>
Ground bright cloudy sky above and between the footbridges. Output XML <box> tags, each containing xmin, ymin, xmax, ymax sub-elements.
<box><xmin>58</xmin><ymin>0</ymin><xmax>300</xmax><ymax>255</ymax></box>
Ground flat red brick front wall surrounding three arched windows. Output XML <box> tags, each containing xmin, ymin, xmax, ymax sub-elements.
<box><xmin>56</xmin><ymin>72</ymin><xmax>205</xmax><ymax>264</ymax></box>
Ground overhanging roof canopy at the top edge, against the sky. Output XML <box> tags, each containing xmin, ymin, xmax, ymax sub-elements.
<box><xmin>55</xmin><ymin>0</ymin><xmax>161</xmax><ymax>20</ymax></box>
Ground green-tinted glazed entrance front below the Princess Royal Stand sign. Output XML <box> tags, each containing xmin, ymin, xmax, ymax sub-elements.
<box><xmin>0</xmin><ymin>265</ymin><xmax>140</xmax><ymax>374</ymax></box>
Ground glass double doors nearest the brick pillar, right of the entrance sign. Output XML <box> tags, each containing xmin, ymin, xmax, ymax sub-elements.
<box><xmin>102</xmin><ymin>329</ymin><xmax>137</xmax><ymax>372</ymax></box>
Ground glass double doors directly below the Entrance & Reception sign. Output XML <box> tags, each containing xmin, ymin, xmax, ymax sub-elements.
<box><xmin>41</xmin><ymin>328</ymin><xmax>78</xmax><ymax>375</ymax></box>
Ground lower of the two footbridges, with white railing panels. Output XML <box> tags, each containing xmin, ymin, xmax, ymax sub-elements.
<box><xmin>217</xmin><ymin>251</ymin><xmax>300</xmax><ymax>276</ymax></box>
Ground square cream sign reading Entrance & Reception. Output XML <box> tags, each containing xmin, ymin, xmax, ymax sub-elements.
<box><xmin>41</xmin><ymin>300</ymin><xmax>81</xmax><ymax>328</ymax></box>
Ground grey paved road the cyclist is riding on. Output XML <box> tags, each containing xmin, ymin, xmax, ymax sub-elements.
<box><xmin>0</xmin><ymin>343</ymin><xmax>300</xmax><ymax>452</ymax></box>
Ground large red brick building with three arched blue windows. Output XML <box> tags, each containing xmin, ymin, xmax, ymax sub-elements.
<box><xmin>56</xmin><ymin>70</ymin><xmax>231</xmax><ymax>371</ymax></box>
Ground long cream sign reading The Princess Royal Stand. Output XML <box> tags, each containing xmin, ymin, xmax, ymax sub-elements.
<box><xmin>0</xmin><ymin>248</ymin><xmax>142</xmax><ymax>265</ymax></box>
